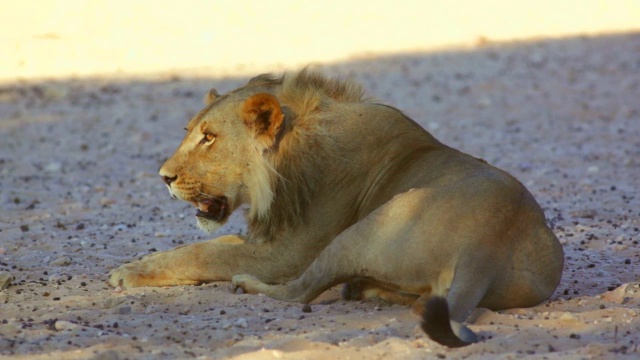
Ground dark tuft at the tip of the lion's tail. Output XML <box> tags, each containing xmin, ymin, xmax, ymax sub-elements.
<box><xmin>420</xmin><ymin>296</ymin><xmax>470</xmax><ymax>347</ymax></box>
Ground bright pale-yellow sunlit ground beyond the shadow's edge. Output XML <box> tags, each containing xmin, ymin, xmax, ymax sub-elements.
<box><xmin>0</xmin><ymin>0</ymin><xmax>640</xmax><ymax>82</ymax></box>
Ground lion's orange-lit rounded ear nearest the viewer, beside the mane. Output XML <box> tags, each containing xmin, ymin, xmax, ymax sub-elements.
<box><xmin>242</xmin><ymin>93</ymin><xmax>284</xmax><ymax>147</ymax></box>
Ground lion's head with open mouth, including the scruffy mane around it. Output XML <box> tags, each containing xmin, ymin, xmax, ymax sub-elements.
<box><xmin>160</xmin><ymin>70</ymin><xmax>364</xmax><ymax>238</ymax></box>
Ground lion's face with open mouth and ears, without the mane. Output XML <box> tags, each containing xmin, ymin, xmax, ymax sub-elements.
<box><xmin>160</xmin><ymin>82</ymin><xmax>284</xmax><ymax>231</ymax></box>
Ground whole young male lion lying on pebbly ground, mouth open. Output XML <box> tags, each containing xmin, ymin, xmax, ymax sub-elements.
<box><xmin>109</xmin><ymin>69</ymin><xmax>563</xmax><ymax>347</ymax></box>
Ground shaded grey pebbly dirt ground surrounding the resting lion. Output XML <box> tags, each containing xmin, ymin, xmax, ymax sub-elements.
<box><xmin>0</xmin><ymin>33</ymin><xmax>640</xmax><ymax>359</ymax></box>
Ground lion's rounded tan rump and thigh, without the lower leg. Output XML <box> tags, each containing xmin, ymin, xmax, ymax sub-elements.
<box><xmin>356</xmin><ymin>165</ymin><xmax>563</xmax><ymax>313</ymax></box>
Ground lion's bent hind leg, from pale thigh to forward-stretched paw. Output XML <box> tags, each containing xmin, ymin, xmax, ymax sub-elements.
<box><xmin>232</xmin><ymin>190</ymin><xmax>440</xmax><ymax>303</ymax></box>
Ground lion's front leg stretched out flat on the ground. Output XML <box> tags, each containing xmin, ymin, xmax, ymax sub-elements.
<box><xmin>109</xmin><ymin>236</ymin><xmax>258</xmax><ymax>288</ymax></box>
